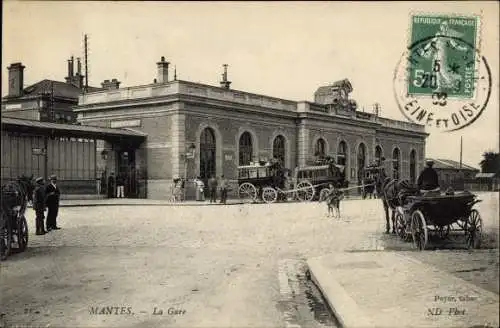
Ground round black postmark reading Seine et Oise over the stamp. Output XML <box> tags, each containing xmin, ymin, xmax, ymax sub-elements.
<box><xmin>394</xmin><ymin>33</ymin><xmax>492</xmax><ymax>132</ymax></box>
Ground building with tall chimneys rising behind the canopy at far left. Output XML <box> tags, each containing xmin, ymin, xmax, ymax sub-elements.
<box><xmin>2</xmin><ymin>57</ymin><xmax>107</xmax><ymax>123</ymax></box>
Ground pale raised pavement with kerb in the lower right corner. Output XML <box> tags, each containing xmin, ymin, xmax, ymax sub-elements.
<box><xmin>307</xmin><ymin>252</ymin><xmax>499</xmax><ymax>328</ymax></box>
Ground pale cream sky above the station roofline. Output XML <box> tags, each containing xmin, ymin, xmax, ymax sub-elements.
<box><xmin>2</xmin><ymin>1</ymin><xmax>500</xmax><ymax>167</ymax></box>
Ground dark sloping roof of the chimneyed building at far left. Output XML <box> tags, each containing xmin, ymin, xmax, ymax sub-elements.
<box><xmin>4</xmin><ymin>79</ymin><xmax>104</xmax><ymax>100</ymax></box>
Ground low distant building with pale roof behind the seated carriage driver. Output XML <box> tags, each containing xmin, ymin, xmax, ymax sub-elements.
<box><xmin>427</xmin><ymin>158</ymin><xmax>479</xmax><ymax>190</ymax></box>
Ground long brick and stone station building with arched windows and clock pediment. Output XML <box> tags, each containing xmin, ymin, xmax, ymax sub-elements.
<box><xmin>73</xmin><ymin>57</ymin><xmax>428</xmax><ymax>199</ymax></box>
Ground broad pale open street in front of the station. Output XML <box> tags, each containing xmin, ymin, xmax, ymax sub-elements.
<box><xmin>1</xmin><ymin>194</ymin><xmax>498</xmax><ymax>327</ymax></box>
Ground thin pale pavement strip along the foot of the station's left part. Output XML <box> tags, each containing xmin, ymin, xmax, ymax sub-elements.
<box><xmin>59</xmin><ymin>198</ymin><xmax>244</xmax><ymax>207</ymax></box>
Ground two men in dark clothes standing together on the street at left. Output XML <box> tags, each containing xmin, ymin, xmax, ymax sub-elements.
<box><xmin>33</xmin><ymin>175</ymin><xmax>61</xmax><ymax>235</ymax></box>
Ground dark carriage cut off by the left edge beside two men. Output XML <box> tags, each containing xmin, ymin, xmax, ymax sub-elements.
<box><xmin>0</xmin><ymin>176</ymin><xmax>33</xmax><ymax>260</ymax></box>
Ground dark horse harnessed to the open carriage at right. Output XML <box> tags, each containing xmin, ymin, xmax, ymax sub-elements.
<box><xmin>375</xmin><ymin>168</ymin><xmax>419</xmax><ymax>233</ymax></box>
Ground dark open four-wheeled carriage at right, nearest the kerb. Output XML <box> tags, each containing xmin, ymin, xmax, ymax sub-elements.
<box><xmin>395</xmin><ymin>191</ymin><xmax>482</xmax><ymax>250</ymax></box>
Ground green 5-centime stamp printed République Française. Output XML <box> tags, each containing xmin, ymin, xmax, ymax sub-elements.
<box><xmin>408</xmin><ymin>15</ymin><xmax>479</xmax><ymax>98</ymax></box>
